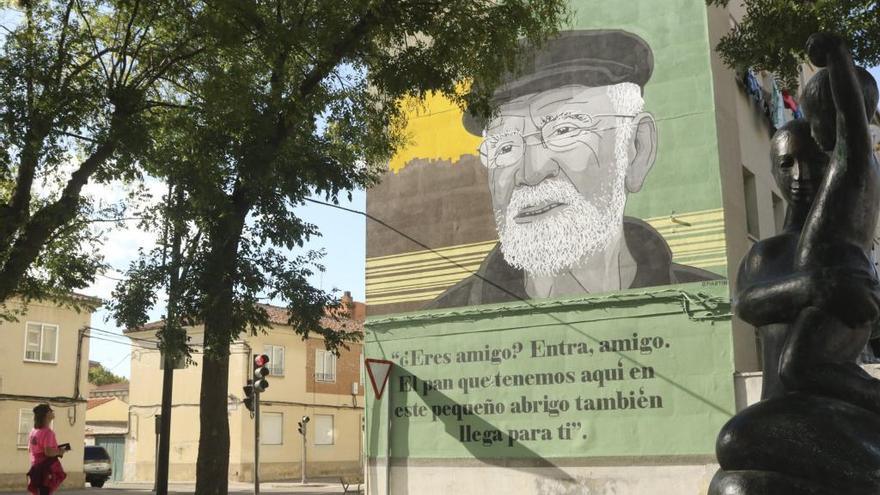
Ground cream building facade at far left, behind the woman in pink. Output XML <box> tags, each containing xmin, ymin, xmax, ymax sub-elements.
<box><xmin>0</xmin><ymin>298</ymin><xmax>100</xmax><ymax>493</ymax></box>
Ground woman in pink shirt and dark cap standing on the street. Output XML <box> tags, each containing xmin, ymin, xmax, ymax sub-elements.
<box><xmin>27</xmin><ymin>404</ymin><xmax>70</xmax><ymax>495</ymax></box>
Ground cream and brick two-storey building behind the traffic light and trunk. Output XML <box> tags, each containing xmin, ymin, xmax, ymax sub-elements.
<box><xmin>124</xmin><ymin>303</ymin><xmax>364</xmax><ymax>481</ymax></box>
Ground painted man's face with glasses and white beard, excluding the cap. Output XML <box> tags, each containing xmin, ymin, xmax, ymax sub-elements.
<box><xmin>480</xmin><ymin>86</ymin><xmax>653</xmax><ymax>275</ymax></box>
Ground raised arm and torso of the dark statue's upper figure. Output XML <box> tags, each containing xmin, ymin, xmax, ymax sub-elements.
<box><xmin>795</xmin><ymin>33</ymin><xmax>880</xmax><ymax>269</ymax></box>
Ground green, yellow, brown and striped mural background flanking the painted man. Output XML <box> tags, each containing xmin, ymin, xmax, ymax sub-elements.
<box><xmin>366</xmin><ymin>0</ymin><xmax>728</xmax><ymax>315</ymax></box>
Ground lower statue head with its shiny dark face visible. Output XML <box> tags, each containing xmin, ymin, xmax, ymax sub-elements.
<box><xmin>770</xmin><ymin>119</ymin><xmax>829</xmax><ymax>206</ymax></box>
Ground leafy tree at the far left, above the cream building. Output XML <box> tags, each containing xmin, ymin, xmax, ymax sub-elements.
<box><xmin>0</xmin><ymin>0</ymin><xmax>199</xmax><ymax>316</ymax></box>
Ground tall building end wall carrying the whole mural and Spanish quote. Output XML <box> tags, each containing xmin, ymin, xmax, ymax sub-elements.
<box><xmin>365</xmin><ymin>0</ymin><xmax>876</xmax><ymax>495</ymax></box>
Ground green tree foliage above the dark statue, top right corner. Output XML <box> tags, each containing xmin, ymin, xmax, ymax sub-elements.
<box><xmin>707</xmin><ymin>0</ymin><xmax>880</xmax><ymax>88</ymax></box>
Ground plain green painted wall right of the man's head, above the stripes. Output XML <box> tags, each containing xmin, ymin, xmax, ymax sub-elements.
<box><xmin>572</xmin><ymin>0</ymin><xmax>721</xmax><ymax>218</ymax></box>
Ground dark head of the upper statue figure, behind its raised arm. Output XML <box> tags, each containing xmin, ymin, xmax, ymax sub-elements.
<box><xmin>801</xmin><ymin>67</ymin><xmax>878</xmax><ymax>151</ymax></box>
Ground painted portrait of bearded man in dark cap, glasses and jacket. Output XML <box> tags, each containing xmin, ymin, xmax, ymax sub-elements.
<box><xmin>427</xmin><ymin>30</ymin><xmax>721</xmax><ymax>308</ymax></box>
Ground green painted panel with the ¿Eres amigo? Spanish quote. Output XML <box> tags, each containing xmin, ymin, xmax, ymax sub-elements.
<box><xmin>365</xmin><ymin>281</ymin><xmax>735</xmax><ymax>459</ymax></box>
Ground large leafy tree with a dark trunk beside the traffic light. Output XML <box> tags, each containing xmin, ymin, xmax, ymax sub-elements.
<box><xmin>108</xmin><ymin>0</ymin><xmax>567</xmax><ymax>494</ymax></box>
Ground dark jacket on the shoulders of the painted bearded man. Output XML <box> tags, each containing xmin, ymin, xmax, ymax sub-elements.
<box><xmin>423</xmin><ymin>217</ymin><xmax>724</xmax><ymax>309</ymax></box>
